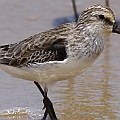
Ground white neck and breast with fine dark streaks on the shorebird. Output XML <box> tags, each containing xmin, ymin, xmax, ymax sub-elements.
<box><xmin>67</xmin><ymin>24</ymin><xmax>109</xmax><ymax>59</ymax></box>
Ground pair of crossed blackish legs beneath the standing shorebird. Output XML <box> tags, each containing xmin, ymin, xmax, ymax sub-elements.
<box><xmin>34</xmin><ymin>81</ymin><xmax>58</xmax><ymax>120</ymax></box>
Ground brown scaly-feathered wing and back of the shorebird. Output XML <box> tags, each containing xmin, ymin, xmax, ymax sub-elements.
<box><xmin>0</xmin><ymin>23</ymin><xmax>74</xmax><ymax>67</ymax></box>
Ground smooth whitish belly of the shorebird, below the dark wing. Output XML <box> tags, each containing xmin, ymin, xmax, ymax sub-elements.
<box><xmin>0</xmin><ymin>56</ymin><xmax>94</xmax><ymax>85</ymax></box>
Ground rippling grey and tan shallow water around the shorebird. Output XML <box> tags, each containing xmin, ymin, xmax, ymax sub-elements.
<box><xmin>0</xmin><ymin>0</ymin><xmax>120</xmax><ymax>120</ymax></box>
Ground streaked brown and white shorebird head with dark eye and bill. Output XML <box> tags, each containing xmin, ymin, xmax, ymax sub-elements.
<box><xmin>76</xmin><ymin>4</ymin><xmax>120</xmax><ymax>34</ymax></box>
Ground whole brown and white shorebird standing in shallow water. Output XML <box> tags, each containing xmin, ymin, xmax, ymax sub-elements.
<box><xmin>0</xmin><ymin>4</ymin><xmax>120</xmax><ymax>120</ymax></box>
